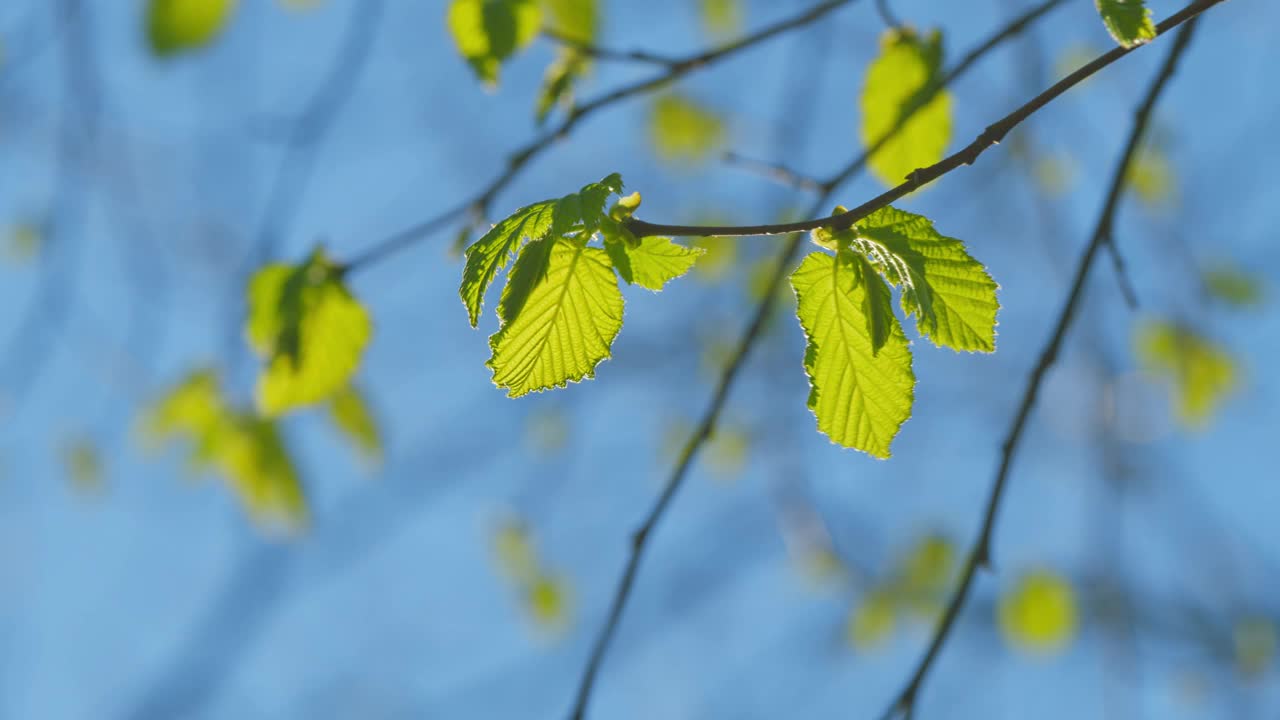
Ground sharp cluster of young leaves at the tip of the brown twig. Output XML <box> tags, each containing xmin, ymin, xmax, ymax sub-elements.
<box><xmin>460</xmin><ymin>174</ymin><xmax>700</xmax><ymax>397</ymax></box>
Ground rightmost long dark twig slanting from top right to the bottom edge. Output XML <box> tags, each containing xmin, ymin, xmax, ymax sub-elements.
<box><xmin>883</xmin><ymin>16</ymin><xmax>1216</xmax><ymax>719</ymax></box>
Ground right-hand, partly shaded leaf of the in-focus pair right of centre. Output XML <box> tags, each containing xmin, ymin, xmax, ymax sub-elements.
<box><xmin>829</xmin><ymin>208</ymin><xmax>1000</xmax><ymax>352</ymax></box>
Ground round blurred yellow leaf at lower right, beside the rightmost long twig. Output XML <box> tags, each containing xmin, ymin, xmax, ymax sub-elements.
<box><xmin>997</xmin><ymin>570</ymin><xmax>1076</xmax><ymax>655</ymax></box>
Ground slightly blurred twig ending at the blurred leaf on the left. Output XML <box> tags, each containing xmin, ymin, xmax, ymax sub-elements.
<box><xmin>346</xmin><ymin>0</ymin><xmax>856</xmax><ymax>270</ymax></box>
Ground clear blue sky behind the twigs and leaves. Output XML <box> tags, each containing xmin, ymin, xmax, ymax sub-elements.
<box><xmin>0</xmin><ymin>0</ymin><xmax>1280</xmax><ymax>719</ymax></box>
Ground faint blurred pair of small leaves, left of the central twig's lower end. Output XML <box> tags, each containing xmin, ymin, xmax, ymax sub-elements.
<box><xmin>493</xmin><ymin>519</ymin><xmax>572</xmax><ymax>632</ymax></box>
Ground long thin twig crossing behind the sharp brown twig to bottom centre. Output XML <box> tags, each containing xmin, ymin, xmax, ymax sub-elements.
<box><xmin>571</xmin><ymin>0</ymin><xmax>1061</xmax><ymax>720</ymax></box>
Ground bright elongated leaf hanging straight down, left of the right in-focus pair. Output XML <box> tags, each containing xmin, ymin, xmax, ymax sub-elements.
<box><xmin>791</xmin><ymin>251</ymin><xmax>915</xmax><ymax>457</ymax></box>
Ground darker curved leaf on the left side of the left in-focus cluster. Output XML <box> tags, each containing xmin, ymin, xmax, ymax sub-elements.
<box><xmin>458</xmin><ymin>173</ymin><xmax>622</xmax><ymax>328</ymax></box>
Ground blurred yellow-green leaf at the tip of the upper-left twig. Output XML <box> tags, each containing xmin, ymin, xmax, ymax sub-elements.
<box><xmin>247</xmin><ymin>249</ymin><xmax>372</xmax><ymax>416</ymax></box>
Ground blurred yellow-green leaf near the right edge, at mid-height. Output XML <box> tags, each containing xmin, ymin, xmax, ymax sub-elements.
<box><xmin>1135</xmin><ymin>320</ymin><xmax>1236</xmax><ymax>428</ymax></box>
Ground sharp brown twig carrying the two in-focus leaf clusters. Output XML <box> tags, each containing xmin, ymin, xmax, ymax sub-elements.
<box><xmin>627</xmin><ymin>0</ymin><xmax>1224</xmax><ymax>237</ymax></box>
